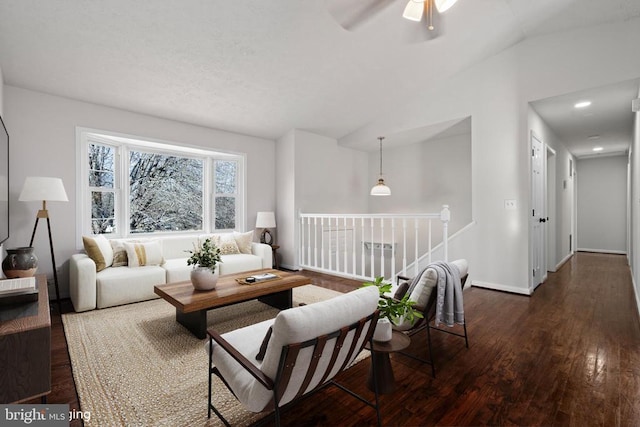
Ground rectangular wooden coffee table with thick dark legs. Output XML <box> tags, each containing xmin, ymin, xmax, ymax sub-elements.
<box><xmin>153</xmin><ymin>269</ymin><xmax>311</xmax><ymax>339</ymax></box>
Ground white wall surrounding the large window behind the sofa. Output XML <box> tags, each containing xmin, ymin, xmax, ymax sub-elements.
<box><xmin>4</xmin><ymin>86</ymin><xmax>275</xmax><ymax>295</ymax></box>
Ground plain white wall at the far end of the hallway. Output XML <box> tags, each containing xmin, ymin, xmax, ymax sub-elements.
<box><xmin>576</xmin><ymin>156</ymin><xmax>627</xmax><ymax>253</ymax></box>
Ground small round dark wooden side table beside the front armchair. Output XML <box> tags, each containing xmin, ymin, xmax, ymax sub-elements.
<box><xmin>366</xmin><ymin>331</ymin><xmax>411</xmax><ymax>394</ymax></box>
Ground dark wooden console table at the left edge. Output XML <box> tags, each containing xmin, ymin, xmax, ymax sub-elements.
<box><xmin>0</xmin><ymin>274</ymin><xmax>51</xmax><ymax>403</ymax></box>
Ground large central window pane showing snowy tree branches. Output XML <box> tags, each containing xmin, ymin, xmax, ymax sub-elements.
<box><xmin>129</xmin><ymin>152</ymin><xmax>204</xmax><ymax>233</ymax></box>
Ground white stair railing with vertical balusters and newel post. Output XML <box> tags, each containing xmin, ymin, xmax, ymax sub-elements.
<box><xmin>299</xmin><ymin>205</ymin><xmax>451</xmax><ymax>280</ymax></box>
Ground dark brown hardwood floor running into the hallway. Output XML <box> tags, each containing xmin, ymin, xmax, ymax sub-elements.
<box><xmin>33</xmin><ymin>253</ymin><xmax>640</xmax><ymax>426</ymax></box>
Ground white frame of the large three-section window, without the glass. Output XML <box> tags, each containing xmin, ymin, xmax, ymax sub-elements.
<box><xmin>76</xmin><ymin>127</ymin><xmax>247</xmax><ymax>248</ymax></box>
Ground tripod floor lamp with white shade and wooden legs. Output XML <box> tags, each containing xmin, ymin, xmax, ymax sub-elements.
<box><xmin>18</xmin><ymin>176</ymin><xmax>69</xmax><ymax>314</ymax></box>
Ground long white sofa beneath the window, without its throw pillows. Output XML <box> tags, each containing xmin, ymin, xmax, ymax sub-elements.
<box><xmin>69</xmin><ymin>236</ymin><xmax>273</xmax><ymax>312</ymax></box>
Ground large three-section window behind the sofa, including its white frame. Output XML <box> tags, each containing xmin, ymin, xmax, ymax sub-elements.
<box><xmin>77</xmin><ymin>130</ymin><xmax>244</xmax><ymax>240</ymax></box>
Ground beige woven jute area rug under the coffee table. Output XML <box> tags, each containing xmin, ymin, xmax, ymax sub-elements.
<box><xmin>62</xmin><ymin>285</ymin><xmax>365</xmax><ymax>426</ymax></box>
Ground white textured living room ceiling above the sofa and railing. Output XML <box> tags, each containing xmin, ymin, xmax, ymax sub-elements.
<box><xmin>0</xmin><ymin>0</ymin><xmax>640</xmax><ymax>152</ymax></box>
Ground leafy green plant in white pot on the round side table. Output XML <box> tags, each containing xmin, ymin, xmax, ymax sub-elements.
<box><xmin>362</xmin><ymin>277</ymin><xmax>424</xmax><ymax>341</ymax></box>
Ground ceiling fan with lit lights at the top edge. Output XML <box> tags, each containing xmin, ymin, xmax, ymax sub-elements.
<box><xmin>325</xmin><ymin>0</ymin><xmax>458</xmax><ymax>41</ymax></box>
